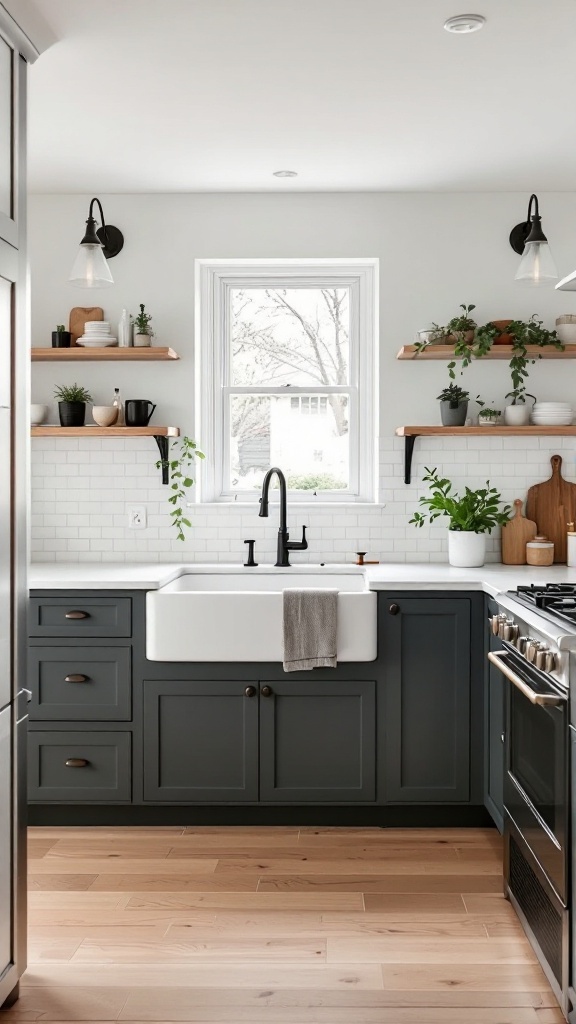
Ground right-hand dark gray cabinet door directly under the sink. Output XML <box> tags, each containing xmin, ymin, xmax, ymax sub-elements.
<box><xmin>260</xmin><ymin>681</ymin><xmax>376</xmax><ymax>804</ymax></box>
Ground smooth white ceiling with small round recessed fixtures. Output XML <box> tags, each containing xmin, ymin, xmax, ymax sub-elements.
<box><xmin>30</xmin><ymin>0</ymin><xmax>576</xmax><ymax>194</ymax></box>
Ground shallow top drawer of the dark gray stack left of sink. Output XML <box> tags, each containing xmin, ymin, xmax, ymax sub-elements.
<box><xmin>30</xmin><ymin>594</ymin><xmax>132</xmax><ymax>637</ymax></box>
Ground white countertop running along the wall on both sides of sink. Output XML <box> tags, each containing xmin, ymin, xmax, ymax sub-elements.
<box><xmin>29</xmin><ymin>562</ymin><xmax>576</xmax><ymax>597</ymax></box>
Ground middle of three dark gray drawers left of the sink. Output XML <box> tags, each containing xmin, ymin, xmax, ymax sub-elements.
<box><xmin>28</xmin><ymin>645</ymin><xmax>132</xmax><ymax>722</ymax></box>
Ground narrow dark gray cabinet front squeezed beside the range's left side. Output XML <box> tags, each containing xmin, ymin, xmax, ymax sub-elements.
<box><xmin>484</xmin><ymin>601</ymin><xmax>505</xmax><ymax>831</ymax></box>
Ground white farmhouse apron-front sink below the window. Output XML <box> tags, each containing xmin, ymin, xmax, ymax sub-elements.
<box><xmin>147</xmin><ymin>566</ymin><xmax>376</xmax><ymax>662</ymax></box>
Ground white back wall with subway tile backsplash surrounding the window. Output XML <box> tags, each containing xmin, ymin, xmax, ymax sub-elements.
<box><xmin>30</xmin><ymin>194</ymin><xmax>576</xmax><ymax>561</ymax></box>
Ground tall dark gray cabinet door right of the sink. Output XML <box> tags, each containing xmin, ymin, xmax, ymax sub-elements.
<box><xmin>379</xmin><ymin>593</ymin><xmax>470</xmax><ymax>803</ymax></box>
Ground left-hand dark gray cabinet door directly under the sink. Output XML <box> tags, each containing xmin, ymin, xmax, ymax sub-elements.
<box><xmin>143</xmin><ymin>680</ymin><xmax>258</xmax><ymax>803</ymax></box>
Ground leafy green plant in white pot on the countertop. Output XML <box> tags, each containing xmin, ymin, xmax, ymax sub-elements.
<box><xmin>410</xmin><ymin>466</ymin><xmax>510</xmax><ymax>568</ymax></box>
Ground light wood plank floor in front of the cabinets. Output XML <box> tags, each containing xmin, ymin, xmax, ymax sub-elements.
<box><xmin>1</xmin><ymin>827</ymin><xmax>563</xmax><ymax>1024</ymax></box>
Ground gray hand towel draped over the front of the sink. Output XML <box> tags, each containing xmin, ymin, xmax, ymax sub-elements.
<box><xmin>284</xmin><ymin>589</ymin><xmax>338</xmax><ymax>672</ymax></box>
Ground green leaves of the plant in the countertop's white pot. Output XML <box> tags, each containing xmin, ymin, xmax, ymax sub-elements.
<box><xmin>410</xmin><ymin>466</ymin><xmax>510</xmax><ymax>534</ymax></box>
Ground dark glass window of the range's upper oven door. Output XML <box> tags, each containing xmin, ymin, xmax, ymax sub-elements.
<box><xmin>508</xmin><ymin>686</ymin><xmax>566</xmax><ymax>836</ymax></box>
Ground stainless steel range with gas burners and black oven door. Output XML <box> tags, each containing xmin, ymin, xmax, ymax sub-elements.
<box><xmin>488</xmin><ymin>584</ymin><xmax>576</xmax><ymax>1020</ymax></box>
